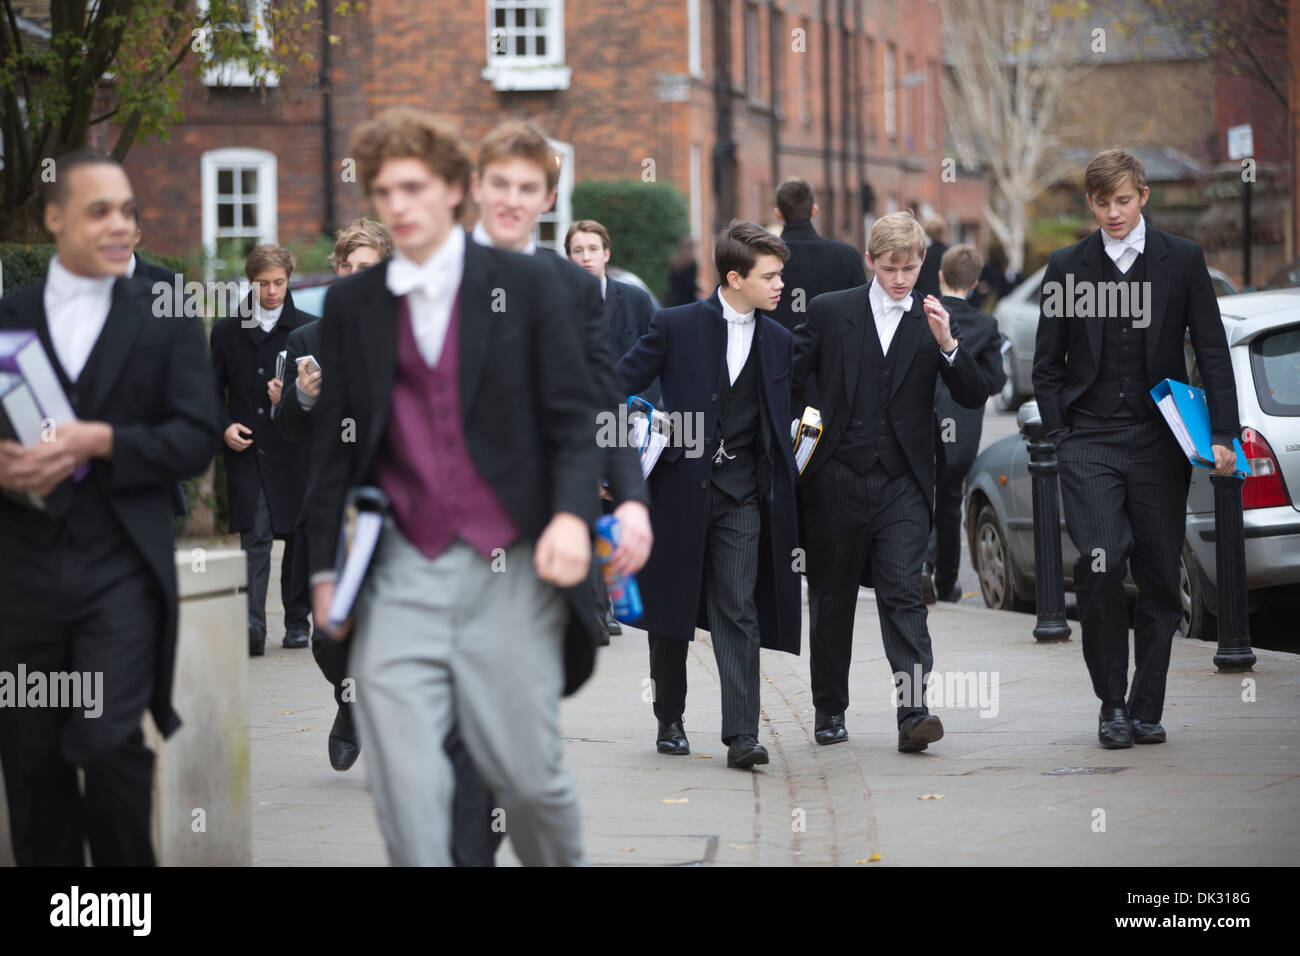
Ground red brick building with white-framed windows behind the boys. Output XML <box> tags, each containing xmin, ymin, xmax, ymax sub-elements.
<box><xmin>114</xmin><ymin>0</ymin><xmax>984</xmax><ymax>278</ymax></box>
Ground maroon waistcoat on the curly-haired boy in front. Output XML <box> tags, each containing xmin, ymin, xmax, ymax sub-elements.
<box><xmin>376</xmin><ymin>290</ymin><xmax>519</xmax><ymax>561</ymax></box>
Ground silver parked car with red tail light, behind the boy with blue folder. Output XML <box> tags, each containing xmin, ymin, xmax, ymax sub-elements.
<box><xmin>966</xmin><ymin>289</ymin><xmax>1300</xmax><ymax>639</ymax></box>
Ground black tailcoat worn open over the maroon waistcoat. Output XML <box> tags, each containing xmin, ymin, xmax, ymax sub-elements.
<box><xmin>306</xmin><ymin>243</ymin><xmax>601</xmax><ymax>693</ymax></box>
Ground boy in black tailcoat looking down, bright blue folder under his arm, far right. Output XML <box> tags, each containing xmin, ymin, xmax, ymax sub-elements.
<box><xmin>1034</xmin><ymin>150</ymin><xmax>1242</xmax><ymax>749</ymax></box>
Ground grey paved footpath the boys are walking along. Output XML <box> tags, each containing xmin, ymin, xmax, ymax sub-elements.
<box><xmin>250</xmin><ymin>562</ymin><xmax>1300</xmax><ymax>866</ymax></box>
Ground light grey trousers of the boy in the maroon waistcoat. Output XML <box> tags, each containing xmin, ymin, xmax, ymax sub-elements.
<box><xmin>352</xmin><ymin>528</ymin><xmax>586</xmax><ymax>866</ymax></box>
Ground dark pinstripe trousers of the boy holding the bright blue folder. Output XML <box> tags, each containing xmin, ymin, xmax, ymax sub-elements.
<box><xmin>1057</xmin><ymin>416</ymin><xmax>1192</xmax><ymax>721</ymax></box>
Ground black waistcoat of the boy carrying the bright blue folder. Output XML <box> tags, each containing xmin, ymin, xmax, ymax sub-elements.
<box><xmin>1071</xmin><ymin>254</ymin><xmax>1156</xmax><ymax>421</ymax></box>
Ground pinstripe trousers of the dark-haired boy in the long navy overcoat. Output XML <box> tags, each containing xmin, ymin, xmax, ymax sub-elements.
<box><xmin>650</xmin><ymin>486</ymin><xmax>762</xmax><ymax>744</ymax></box>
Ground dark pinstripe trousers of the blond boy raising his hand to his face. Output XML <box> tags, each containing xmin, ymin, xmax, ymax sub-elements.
<box><xmin>800</xmin><ymin>458</ymin><xmax>935</xmax><ymax>723</ymax></box>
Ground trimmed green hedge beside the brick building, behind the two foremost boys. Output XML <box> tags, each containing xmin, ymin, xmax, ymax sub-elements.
<box><xmin>572</xmin><ymin>179</ymin><xmax>690</xmax><ymax>299</ymax></box>
